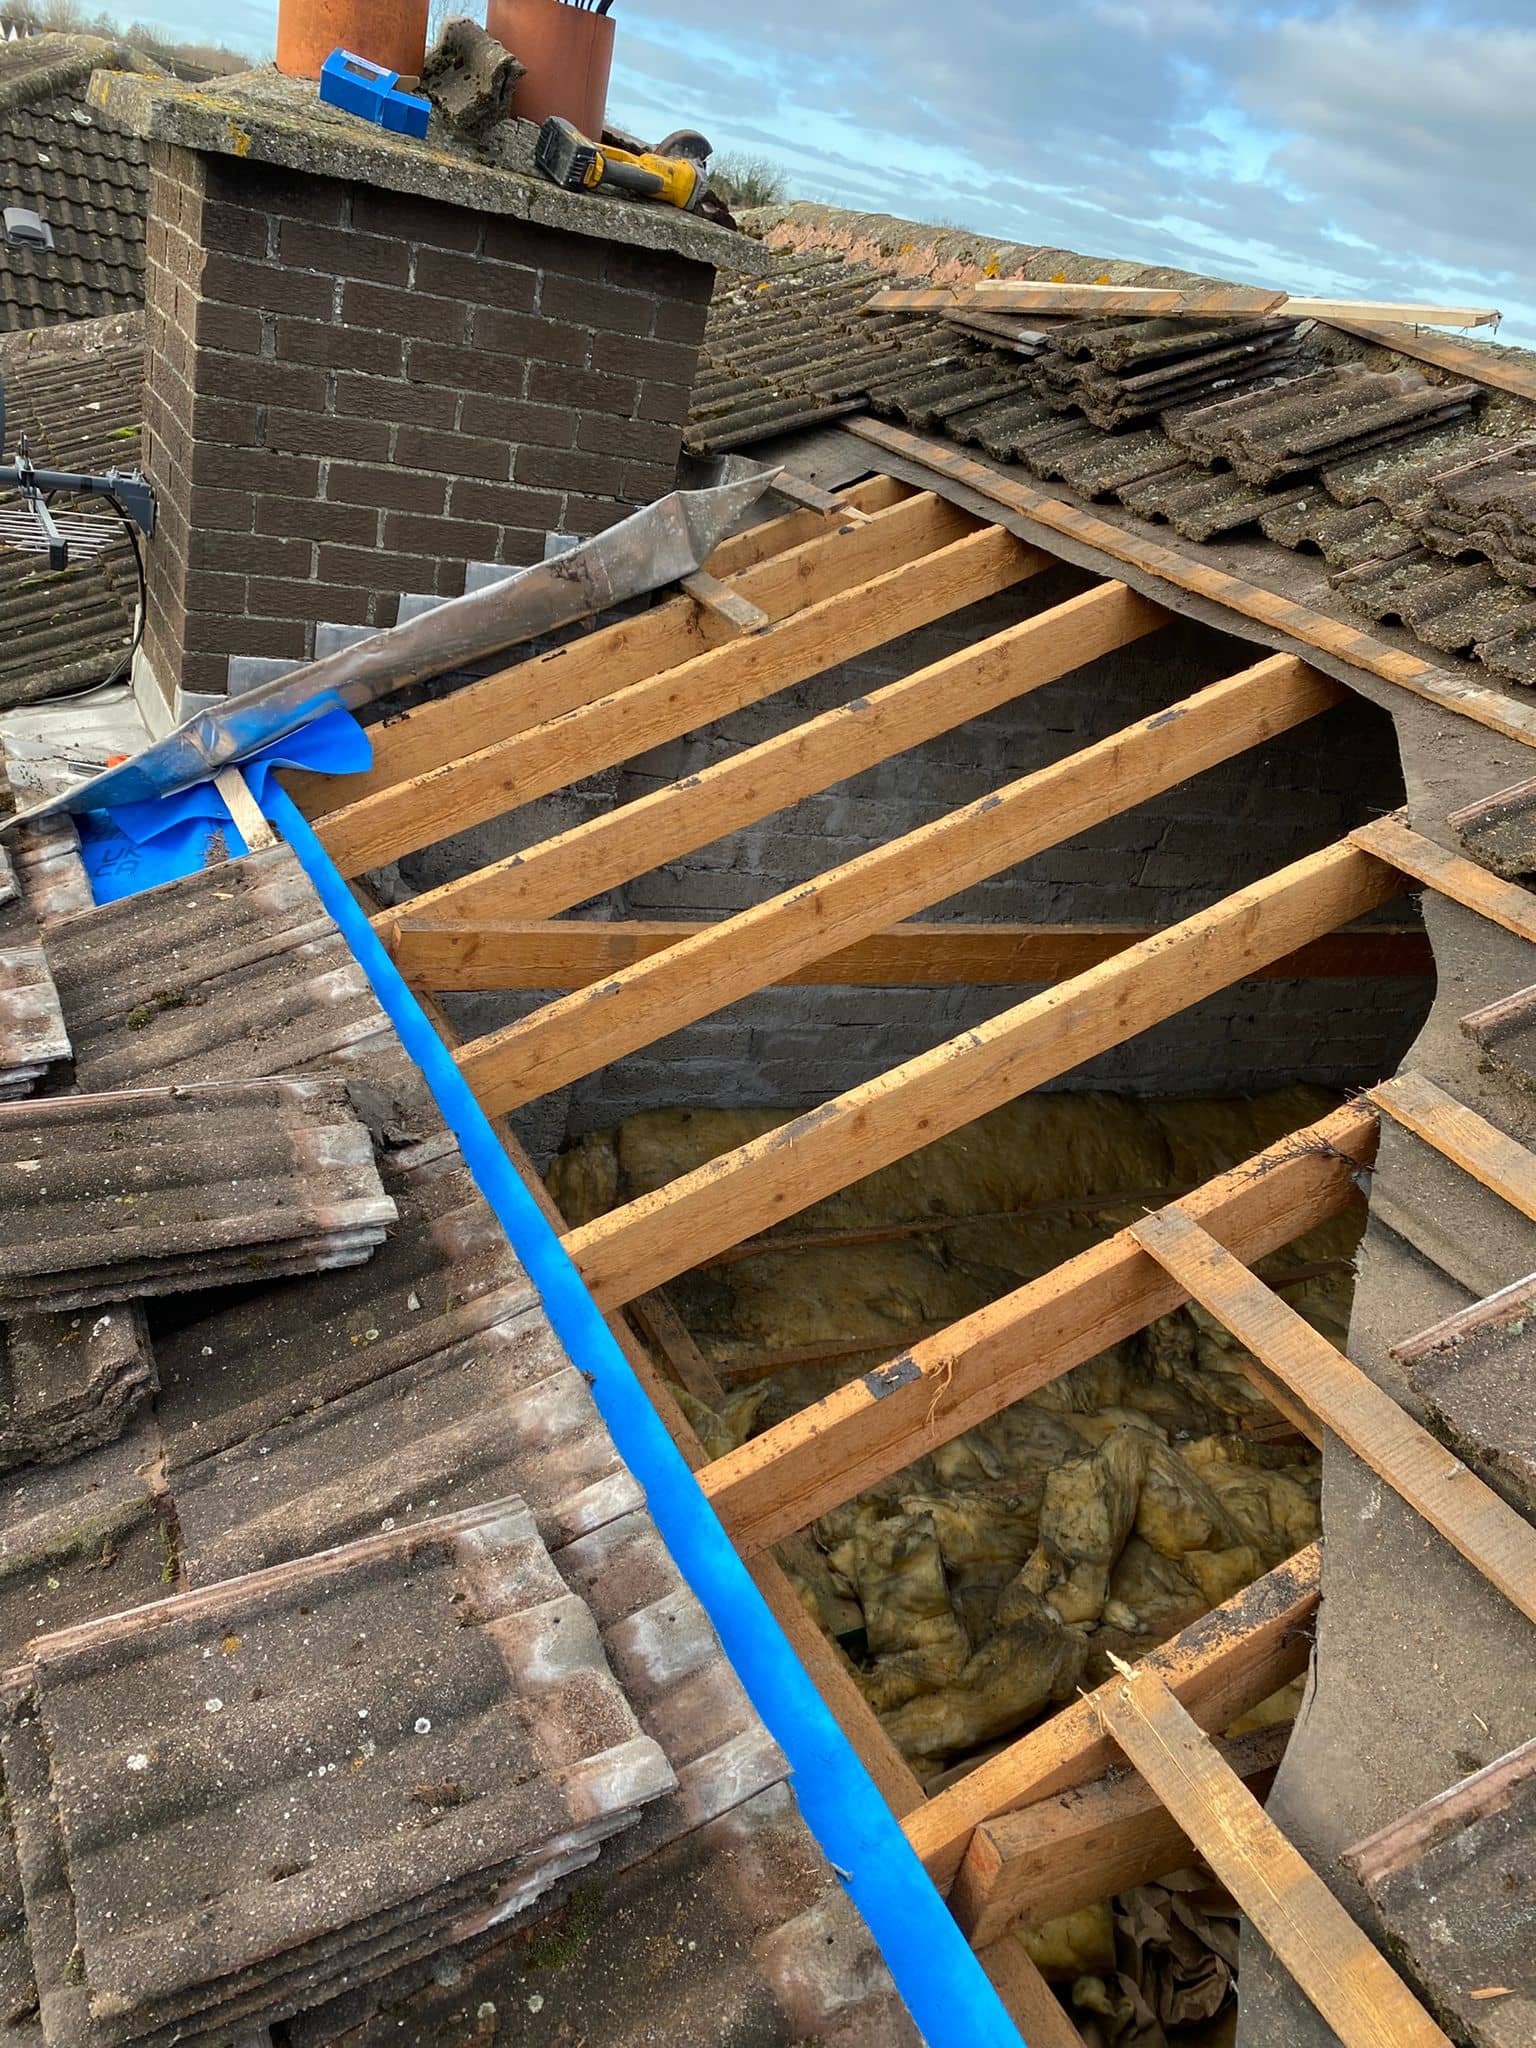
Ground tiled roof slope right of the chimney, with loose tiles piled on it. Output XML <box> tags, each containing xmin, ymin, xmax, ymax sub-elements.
<box><xmin>688</xmin><ymin>205</ymin><xmax>1536</xmax><ymax>684</ymax></box>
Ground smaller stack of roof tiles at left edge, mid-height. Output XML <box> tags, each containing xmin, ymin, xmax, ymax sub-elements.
<box><xmin>0</xmin><ymin>1073</ymin><xmax>397</xmax><ymax>1315</ymax></box>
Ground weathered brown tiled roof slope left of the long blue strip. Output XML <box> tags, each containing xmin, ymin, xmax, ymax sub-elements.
<box><xmin>0</xmin><ymin>825</ymin><xmax>918</xmax><ymax>2048</ymax></box>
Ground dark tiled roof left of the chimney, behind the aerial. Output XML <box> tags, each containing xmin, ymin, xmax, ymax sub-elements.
<box><xmin>0</xmin><ymin>311</ymin><xmax>143</xmax><ymax>711</ymax></box>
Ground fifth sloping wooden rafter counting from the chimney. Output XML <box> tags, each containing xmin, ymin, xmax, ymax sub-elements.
<box><xmin>569</xmin><ymin>844</ymin><xmax>1401</xmax><ymax>1307</ymax></box>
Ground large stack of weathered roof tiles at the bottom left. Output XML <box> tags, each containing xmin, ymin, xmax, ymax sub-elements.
<box><xmin>0</xmin><ymin>1501</ymin><xmax>674</xmax><ymax>2048</ymax></box>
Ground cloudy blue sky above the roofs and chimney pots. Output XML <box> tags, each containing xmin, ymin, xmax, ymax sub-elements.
<box><xmin>114</xmin><ymin>0</ymin><xmax>1536</xmax><ymax>346</ymax></box>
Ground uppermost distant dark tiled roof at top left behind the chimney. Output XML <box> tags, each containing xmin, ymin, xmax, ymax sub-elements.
<box><xmin>0</xmin><ymin>35</ymin><xmax>150</xmax><ymax>332</ymax></box>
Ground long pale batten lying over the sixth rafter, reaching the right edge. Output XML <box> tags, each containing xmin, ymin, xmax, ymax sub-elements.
<box><xmin>1130</xmin><ymin>1202</ymin><xmax>1536</xmax><ymax>1622</ymax></box>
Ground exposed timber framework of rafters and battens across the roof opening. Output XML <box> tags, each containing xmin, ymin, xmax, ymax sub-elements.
<box><xmin>303</xmin><ymin>468</ymin><xmax>1536</xmax><ymax>2048</ymax></box>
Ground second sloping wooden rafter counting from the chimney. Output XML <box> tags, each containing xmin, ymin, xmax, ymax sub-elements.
<box><xmin>315</xmin><ymin>520</ymin><xmax>1047</xmax><ymax>874</ymax></box>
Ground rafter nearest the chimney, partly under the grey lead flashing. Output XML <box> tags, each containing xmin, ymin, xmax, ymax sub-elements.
<box><xmin>285</xmin><ymin>479</ymin><xmax>977</xmax><ymax>817</ymax></box>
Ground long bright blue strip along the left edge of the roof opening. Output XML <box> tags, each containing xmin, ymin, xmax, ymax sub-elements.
<box><xmin>264</xmin><ymin>784</ymin><xmax>1022</xmax><ymax>2048</ymax></box>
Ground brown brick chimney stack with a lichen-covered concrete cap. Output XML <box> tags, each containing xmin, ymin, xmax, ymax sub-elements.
<box><xmin>96</xmin><ymin>74</ymin><xmax>752</xmax><ymax>716</ymax></box>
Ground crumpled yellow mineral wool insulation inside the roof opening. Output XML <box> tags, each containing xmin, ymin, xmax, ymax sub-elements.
<box><xmin>551</xmin><ymin>1087</ymin><xmax>1362</xmax><ymax>1777</ymax></box>
